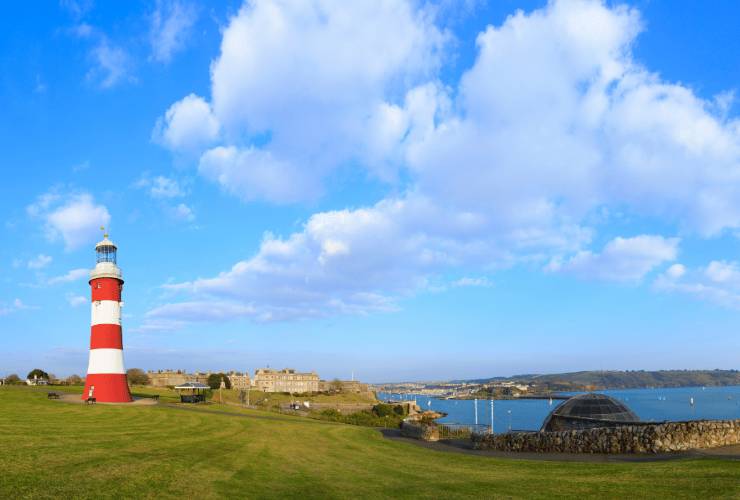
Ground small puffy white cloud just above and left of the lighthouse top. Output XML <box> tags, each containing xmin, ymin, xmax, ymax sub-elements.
<box><xmin>26</xmin><ymin>192</ymin><xmax>110</xmax><ymax>250</ymax></box>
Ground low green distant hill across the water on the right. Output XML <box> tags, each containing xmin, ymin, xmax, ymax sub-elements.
<box><xmin>469</xmin><ymin>370</ymin><xmax>740</xmax><ymax>391</ymax></box>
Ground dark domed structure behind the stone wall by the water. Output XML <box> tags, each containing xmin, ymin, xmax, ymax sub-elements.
<box><xmin>541</xmin><ymin>393</ymin><xmax>640</xmax><ymax>431</ymax></box>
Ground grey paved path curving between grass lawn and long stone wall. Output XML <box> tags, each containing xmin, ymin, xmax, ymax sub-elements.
<box><xmin>380</xmin><ymin>429</ymin><xmax>740</xmax><ymax>463</ymax></box>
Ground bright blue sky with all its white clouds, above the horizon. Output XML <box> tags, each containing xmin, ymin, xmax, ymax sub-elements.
<box><xmin>0</xmin><ymin>0</ymin><xmax>740</xmax><ymax>381</ymax></box>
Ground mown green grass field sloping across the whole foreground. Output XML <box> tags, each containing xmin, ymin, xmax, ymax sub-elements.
<box><xmin>0</xmin><ymin>387</ymin><xmax>740</xmax><ymax>498</ymax></box>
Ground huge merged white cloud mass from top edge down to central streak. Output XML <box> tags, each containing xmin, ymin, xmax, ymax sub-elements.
<box><xmin>147</xmin><ymin>0</ymin><xmax>740</xmax><ymax>328</ymax></box>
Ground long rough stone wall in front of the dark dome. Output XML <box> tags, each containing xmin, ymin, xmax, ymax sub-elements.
<box><xmin>472</xmin><ymin>420</ymin><xmax>740</xmax><ymax>453</ymax></box>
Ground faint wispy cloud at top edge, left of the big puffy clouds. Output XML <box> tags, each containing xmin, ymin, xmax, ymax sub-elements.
<box><xmin>149</xmin><ymin>0</ymin><xmax>198</xmax><ymax>63</ymax></box>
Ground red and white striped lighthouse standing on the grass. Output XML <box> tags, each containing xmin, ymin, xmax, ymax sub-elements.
<box><xmin>82</xmin><ymin>230</ymin><xmax>132</xmax><ymax>403</ymax></box>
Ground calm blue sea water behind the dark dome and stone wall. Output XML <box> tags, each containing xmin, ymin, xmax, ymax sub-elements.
<box><xmin>378</xmin><ymin>386</ymin><xmax>740</xmax><ymax>432</ymax></box>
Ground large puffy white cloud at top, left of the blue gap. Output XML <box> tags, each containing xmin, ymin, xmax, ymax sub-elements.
<box><xmin>155</xmin><ymin>0</ymin><xmax>447</xmax><ymax>202</ymax></box>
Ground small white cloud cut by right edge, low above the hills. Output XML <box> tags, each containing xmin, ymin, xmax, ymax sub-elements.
<box><xmin>653</xmin><ymin>260</ymin><xmax>740</xmax><ymax>309</ymax></box>
